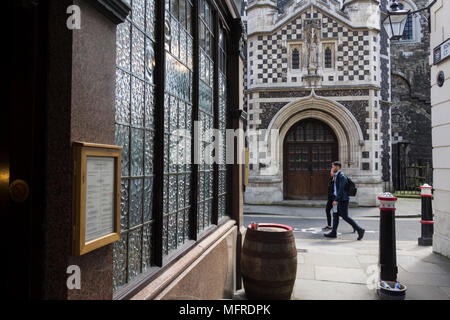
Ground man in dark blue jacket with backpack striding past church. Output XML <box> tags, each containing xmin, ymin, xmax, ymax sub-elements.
<box><xmin>325</xmin><ymin>161</ymin><xmax>365</xmax><ymax>240</ymax></box>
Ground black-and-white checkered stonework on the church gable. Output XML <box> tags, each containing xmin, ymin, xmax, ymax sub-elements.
<box><xmin>248</xmin><ymin>11</ymin><xmax>370</xmax><ymax>84</ymax></box>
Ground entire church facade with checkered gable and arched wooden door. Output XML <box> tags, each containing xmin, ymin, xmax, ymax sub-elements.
<box><xmin>241</xmin><ymin>0</ymin><xmax>392</xmax><ymax>206</ymax></box>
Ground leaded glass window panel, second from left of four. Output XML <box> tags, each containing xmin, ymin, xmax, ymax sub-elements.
<box><xmin>162</xmin><ymin>0</ymin><xmax>194</xmax><ymax>256</ymax></box>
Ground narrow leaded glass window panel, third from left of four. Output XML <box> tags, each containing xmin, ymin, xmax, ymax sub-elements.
<box><xmin>197</xmin><ymin>0</ymin><xmax>215</xmax><ymax>232</ymax></box>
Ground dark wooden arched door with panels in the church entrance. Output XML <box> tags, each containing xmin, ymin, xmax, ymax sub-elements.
<box><xmin>283</xmin><ymin>119</ymin><xmax>339</xmax><ymax>200</ymax></box>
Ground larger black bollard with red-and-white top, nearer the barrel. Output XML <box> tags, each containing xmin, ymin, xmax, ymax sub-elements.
<box><xmin>378</xmin><ymin>193</ymin><xmax>398</xmax><ymax>282</ymax></box>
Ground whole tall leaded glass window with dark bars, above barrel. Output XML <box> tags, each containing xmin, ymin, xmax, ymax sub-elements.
<box><xmin>114</xmin><ymin>0</ymin><xmax>229</xmax><ymax>291</ymax></box>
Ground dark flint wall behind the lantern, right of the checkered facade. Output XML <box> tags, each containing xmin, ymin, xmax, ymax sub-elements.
<box><xmin>391</xmin><ymin>0</ymin><xmax>432</xmax><ymax>190</ymax></box>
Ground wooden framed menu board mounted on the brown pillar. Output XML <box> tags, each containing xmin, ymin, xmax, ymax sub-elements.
<box><xmin>73</xmin><ymin>142</ymin><xmax>122</xmax><ymax>256</ymax></box>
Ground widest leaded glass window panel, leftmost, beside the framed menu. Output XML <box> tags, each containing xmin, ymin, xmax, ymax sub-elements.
<box><xmin>114</xmin><ymin>0</ymin><xmax>155</xmax><ymax>289</ymax></box>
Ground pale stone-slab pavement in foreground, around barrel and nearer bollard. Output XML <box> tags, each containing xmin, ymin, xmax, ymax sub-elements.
<box><xmin>233</xmin><ymin>239</ymin><xmax>450</xmax><ymax>300</ymax></box>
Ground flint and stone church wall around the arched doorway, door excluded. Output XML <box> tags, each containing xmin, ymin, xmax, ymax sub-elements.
<box><xmin>245</xmin><ymin>0</ymin><xmax>384</xmax><ymax>205</ymax></box>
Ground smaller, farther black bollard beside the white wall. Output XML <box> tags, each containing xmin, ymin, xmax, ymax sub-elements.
<box><xmin>419</xmin><ymin>184</ymin><xmax>434</xmax><ymax>246</ymax></box>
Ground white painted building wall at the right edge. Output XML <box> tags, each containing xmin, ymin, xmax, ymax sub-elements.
<box><xmin>430</xmin><ymin>0</ymin><xmax>450</xmax><ymax>257</ymax></box>
